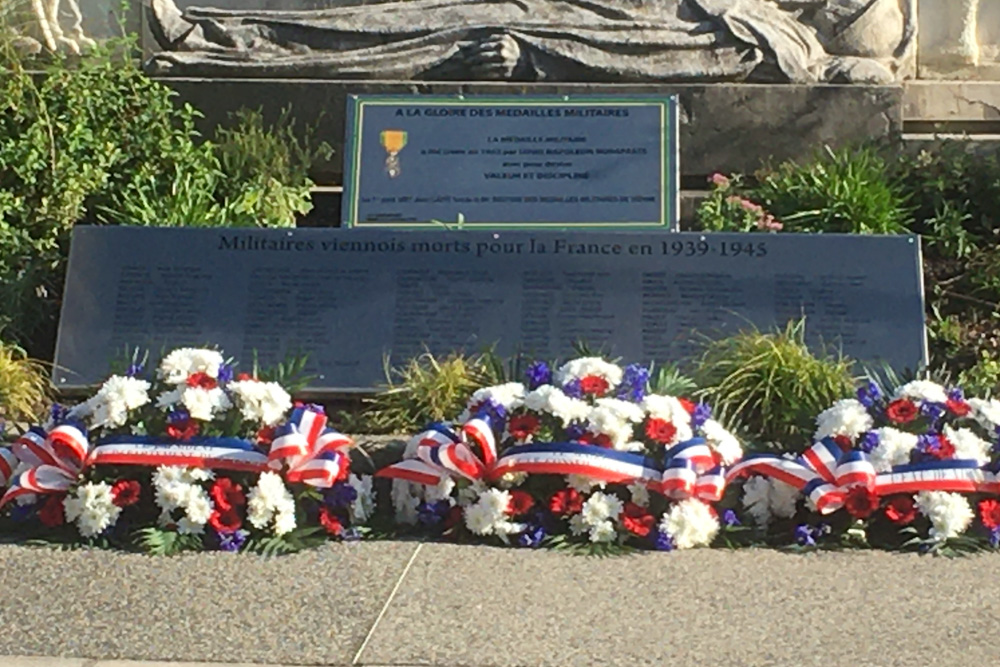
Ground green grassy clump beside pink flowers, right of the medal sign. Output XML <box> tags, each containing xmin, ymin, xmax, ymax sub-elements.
<box><xmin>747</xmin><ymin>145</ymin><xmax>909</xmax><ymax>234</ymax></box>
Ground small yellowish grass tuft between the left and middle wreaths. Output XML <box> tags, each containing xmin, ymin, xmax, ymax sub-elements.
<box><xmin>345</xmin><ymin>352</ymin><xmax>503</xmax><ymax>433</ymax></box>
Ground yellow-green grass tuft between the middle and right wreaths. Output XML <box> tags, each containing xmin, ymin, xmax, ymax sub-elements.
<box><xmin>694</xmin><ymin>319</ymin><xmax>855</xmax><ymax>450</ymax></box>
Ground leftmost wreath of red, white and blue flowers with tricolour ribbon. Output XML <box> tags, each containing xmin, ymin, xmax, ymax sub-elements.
<box><xmin>0</xmin><ymin>348</ymin><xmax>374</xmax><ymax>554</ymax></box>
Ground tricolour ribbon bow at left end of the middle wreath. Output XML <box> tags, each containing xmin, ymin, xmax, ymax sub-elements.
<box><xmin>376</xmin><ymin>417</ymin><xmax>502</xmax><ymax>486</ymax></box>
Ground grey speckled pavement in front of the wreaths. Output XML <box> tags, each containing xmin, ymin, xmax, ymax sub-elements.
<box><xmin>0</xmin><ymin>542</ymin><xmax>1000</xmax><ymax>667</ymax></box>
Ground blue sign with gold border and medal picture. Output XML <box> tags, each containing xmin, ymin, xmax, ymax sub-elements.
<box><xmin>342</xmin><ymin>96</ymin><xmax>679</xmax><ymax>229</ymax></box>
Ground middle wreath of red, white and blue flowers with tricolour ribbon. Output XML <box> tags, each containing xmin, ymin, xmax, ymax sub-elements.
<box><xmin>377</xmin><ymin>357</ymin><xmax>742</xmax><ymax>551</ymax></box>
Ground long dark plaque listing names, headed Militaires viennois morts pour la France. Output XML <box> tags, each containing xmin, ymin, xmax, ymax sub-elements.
<box><xmin>55</xmin><ymin>227</ymin><xmax>926</xmax><ymax>391</ymax></box>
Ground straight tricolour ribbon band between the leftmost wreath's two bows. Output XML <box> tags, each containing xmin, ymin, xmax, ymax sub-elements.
<box><xmin>86</xmin><ymin>435</ymin><xmax>268</xmax><ymax>472</ymax></box>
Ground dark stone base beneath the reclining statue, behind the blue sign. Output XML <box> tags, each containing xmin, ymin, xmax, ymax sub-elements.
<box><xmin>159</xmin><ymin>77</ymin><xmax>903</xmax><ymax>184</ymax></box>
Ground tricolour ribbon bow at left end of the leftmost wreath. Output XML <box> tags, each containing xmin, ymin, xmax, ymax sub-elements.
<box><xmin>0</xmin><ymin>424</ymin><xmax>90</xmax><ymax>507</ymax></box>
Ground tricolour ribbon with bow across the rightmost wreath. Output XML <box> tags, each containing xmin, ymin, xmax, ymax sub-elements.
<box><xmin>726</xmin><ymin>438</ymin><xmax>1000</xmax><ymax>514</ymax></box>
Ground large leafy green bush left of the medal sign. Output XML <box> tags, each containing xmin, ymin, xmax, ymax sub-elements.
<box><xmin>0</xmin><ymin>37</ymin><xmax>320</xmax><ymax>357</ymax></box>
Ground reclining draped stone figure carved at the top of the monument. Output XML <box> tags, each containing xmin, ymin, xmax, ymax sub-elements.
<box><xmin>149</xmin><ymin>0</ymin><xmax>917</xmax><ymax>83</ymax></box>
